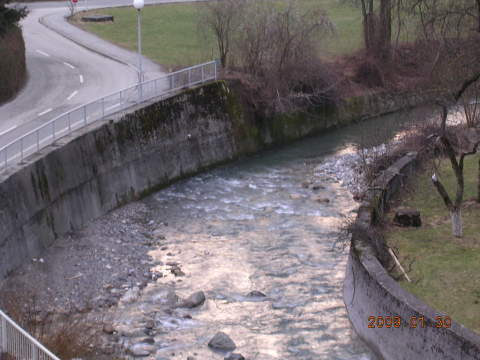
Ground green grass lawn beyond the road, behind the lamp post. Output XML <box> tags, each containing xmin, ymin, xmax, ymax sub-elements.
<box><xmin>72</xmin><ymin>0</ymin><xmax>362</xmax><ymax>69</ymax></box>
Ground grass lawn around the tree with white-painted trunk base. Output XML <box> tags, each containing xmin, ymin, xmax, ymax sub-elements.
<box><xmin>387</xmin><ymin>156</ymin><xmax>480</xmax><ymax>333</ymax></box>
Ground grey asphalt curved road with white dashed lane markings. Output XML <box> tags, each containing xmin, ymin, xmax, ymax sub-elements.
<box><xmin>0</xmin><ymin>0</ymin><xmax>178</xmax><ymax>146</ymax></box>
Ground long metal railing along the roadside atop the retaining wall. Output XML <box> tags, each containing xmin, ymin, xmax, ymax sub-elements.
<box><xmin>0</xmin><ymin>61</ymin><xmax>218</xmax><ymax>170</ymax></box>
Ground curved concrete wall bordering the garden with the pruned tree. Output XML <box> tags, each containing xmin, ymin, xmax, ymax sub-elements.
<box><xmin>344</xmin><ymin>154</ymin><xmax>480</xmax><ymax>360</ymax></box>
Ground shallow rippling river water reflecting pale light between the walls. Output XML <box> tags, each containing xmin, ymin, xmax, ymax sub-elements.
<box><xmin>106</xmin><ymin>107</ymin><xmax>428</xmax><ymax>360</ymax></box>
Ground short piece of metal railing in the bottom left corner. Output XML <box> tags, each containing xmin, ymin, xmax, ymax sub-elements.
<box><xmin>0</xmin><ymin>310</ymin><xmax>60</xmax><ymax>360</ymax></box>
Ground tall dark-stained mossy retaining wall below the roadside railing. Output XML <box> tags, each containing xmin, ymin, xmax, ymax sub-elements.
<box><xmin>0</xmin><ymin>82</ymin><xmax>432</xmax><ymax>279</ymax></box>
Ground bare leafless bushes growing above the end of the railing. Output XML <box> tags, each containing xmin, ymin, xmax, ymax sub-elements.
<box><xmin>202</xmin><ymin>0</ymin><xmax>335</xmax><ymax>112</ymax></box>
